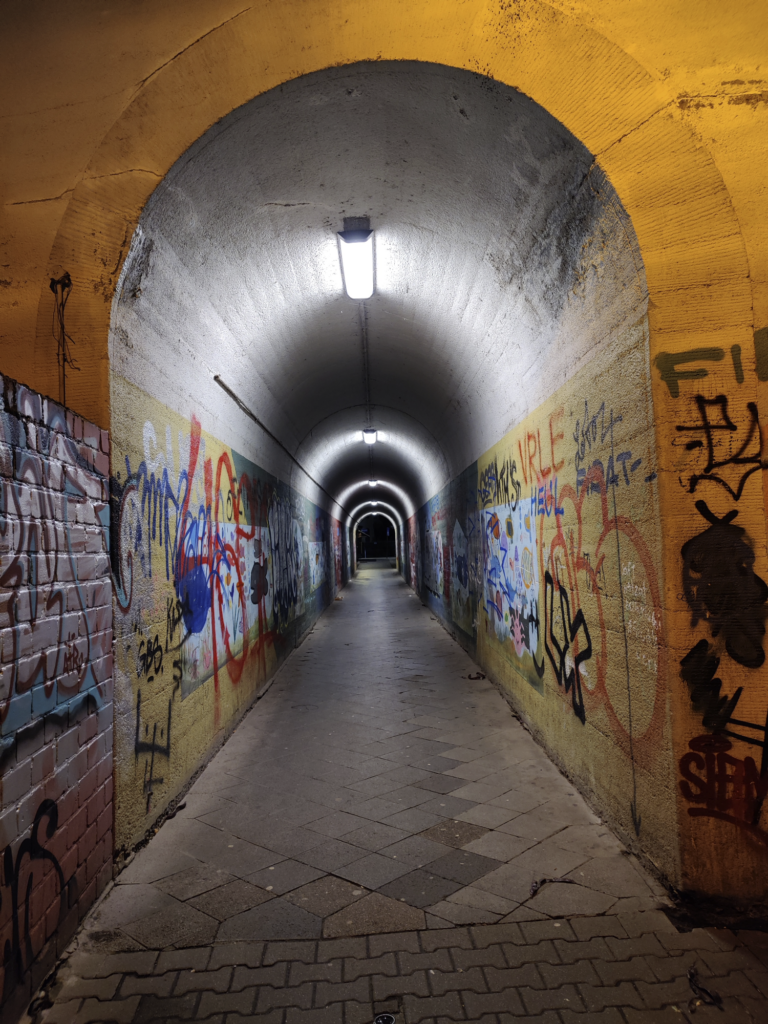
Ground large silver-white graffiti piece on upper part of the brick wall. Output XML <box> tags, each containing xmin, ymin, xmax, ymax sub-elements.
<box><xmin>0</xmin><ymin>399</ymin><xmax>112</xmax><ymax>750</ymax></box>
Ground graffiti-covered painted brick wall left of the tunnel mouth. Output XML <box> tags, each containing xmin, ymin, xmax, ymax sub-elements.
<box><xmin>0</xmin><ymin>377</ymin><xmax>113</xmax><ymax>1019</ymax></box>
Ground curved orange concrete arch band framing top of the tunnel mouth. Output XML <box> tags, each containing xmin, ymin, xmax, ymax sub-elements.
<box><xmin>36</xmin><ymin>0</ymin><xmax>753</xmax><ymax>426</ymax></box>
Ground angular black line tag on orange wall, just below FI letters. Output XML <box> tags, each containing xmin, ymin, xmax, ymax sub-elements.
<box><xmin>677</xmin><ymin>394</ymin><xmax>766</xmax><ymax>501</ymax></box>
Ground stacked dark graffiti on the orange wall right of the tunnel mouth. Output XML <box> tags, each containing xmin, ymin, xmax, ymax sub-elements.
<box><xmin>655</xmin><ymin>335</ymin><xmax>768</xmax><ymax>845</ymax></box>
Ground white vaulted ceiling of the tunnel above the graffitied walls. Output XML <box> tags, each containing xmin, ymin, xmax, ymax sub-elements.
<box><xmin>111</xmin><ymin>62</ymin><xmax>646</xmax><ymax>514</ymax></box>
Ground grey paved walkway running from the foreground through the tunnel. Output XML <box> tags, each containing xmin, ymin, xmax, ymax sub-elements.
<box><xmin>35</xmin><ymin>568</ymin><xmax>768</xmax><ymax>1024</ymax></box>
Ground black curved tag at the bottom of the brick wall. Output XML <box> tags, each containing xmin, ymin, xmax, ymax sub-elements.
<box><xmin>0</xmin><ymin>800</ymin><xmax>77</xmax><ymax>995</ymax></box>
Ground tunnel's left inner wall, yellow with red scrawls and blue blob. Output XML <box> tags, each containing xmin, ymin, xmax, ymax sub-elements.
<box><xmin>111</xmin><ymin>377</ymin><xmax>347</xmax><ymax>850</ymax></box>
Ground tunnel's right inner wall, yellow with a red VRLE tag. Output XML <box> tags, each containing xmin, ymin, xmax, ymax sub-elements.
<box><xmin>409</xmin><ymin>317</ymin><xmax>679</xmax><ymax>879</ymax></box>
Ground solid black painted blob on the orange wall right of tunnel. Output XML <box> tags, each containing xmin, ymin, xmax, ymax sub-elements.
<box><xmin>681</xmin><ymin>501</ymin><xmax>768</xmax><ymax>669</ymax></box>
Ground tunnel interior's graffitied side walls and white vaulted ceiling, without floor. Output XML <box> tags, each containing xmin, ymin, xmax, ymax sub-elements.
<box><xmin>110</xmin><ymin>61</ymin><xmax>677</xmax><ymax>888</ymax></box>
